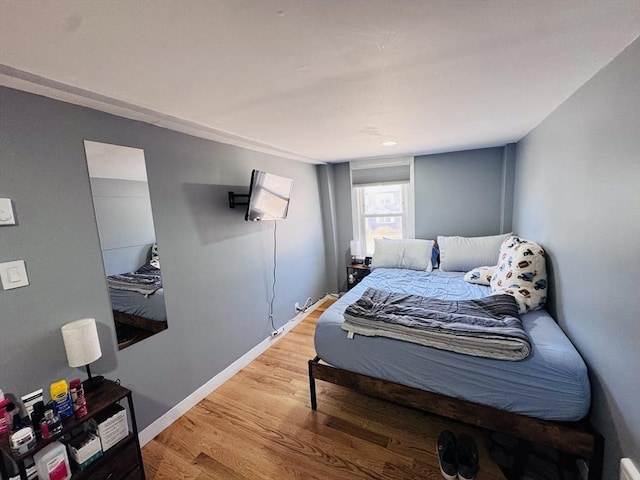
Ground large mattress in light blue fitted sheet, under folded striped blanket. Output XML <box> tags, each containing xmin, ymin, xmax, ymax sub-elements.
<box><xmin>315</xmin><ymin>268</ymin><xmax>591</xmax><ymax>421</ymax></box>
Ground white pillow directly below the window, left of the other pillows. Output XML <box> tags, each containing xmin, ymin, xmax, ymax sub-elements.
<box><xmin>371</xmin><ymin>238</ymin><xmax>435</xmax><ymax>272</ymax></box>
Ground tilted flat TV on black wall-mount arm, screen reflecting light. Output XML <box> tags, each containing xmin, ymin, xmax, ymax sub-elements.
<box><xmin>244</xmin><ymin>170</ymin><xmax>293</xmax><ymax>222</ymax></box>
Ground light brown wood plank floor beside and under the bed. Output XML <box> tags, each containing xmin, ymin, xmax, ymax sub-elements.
<box><xmin>142</xmin><ymin>302</ymin><xmax>504</xmax><ymax>480</ymax></box>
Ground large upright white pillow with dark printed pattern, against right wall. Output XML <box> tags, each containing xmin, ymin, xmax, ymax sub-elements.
<box><xmin>491</xmin><ymin>235</ymin><xmax>547</xmax><ymax>313</ymax></box>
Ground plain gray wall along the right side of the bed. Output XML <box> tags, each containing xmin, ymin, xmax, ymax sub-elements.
<box><xmin>514</xmin><ymin>36</ymin><xmax>640</xmax><ymax>479</ymax></box>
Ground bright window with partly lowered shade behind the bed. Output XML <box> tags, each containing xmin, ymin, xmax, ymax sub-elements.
<box><xmin>350</xmin><ymin>158</ymin><xmax>415</xmax><ymax>255</ymax></box>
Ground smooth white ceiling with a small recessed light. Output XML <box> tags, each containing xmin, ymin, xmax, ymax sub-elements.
<box><xmin>0</xmin><ymin>0</ymin><xmax>640</xmax><ymax>162</ymax></box>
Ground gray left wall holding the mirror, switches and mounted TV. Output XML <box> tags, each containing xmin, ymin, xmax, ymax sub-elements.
<box><xmin>0</xmin><ymin>88</ymin><xmax>327</xmax><ymax>428</ymax></box>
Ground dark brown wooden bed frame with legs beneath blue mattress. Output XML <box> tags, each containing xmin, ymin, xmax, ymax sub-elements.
<box><xmin>309</xmin><ymin>356</ymin><xmax>604</xmax><ymax>480</ymax></box>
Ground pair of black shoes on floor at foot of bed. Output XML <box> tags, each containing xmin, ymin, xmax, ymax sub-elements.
<box><xmin>437</xmin><ymin>430</ymin><xmax>479</xmax><ymax>480</ymax></box>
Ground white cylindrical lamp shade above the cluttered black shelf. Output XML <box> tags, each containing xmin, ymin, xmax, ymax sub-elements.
<box><xmin>61</xmin><ymin>318</ymin><xmax>102</xmax><ymax>367</ymax></box>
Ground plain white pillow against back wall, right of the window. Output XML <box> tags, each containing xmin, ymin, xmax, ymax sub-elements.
<box><xmin>438</xmin><ymin>233</ymin><xmax>511</xmax><ymax>272</ymax></box>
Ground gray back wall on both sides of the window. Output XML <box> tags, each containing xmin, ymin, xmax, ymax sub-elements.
<box><xmin>333</xmin><ymin>144</ymin><xmax>515</xmax><ymax>290</ymax></box>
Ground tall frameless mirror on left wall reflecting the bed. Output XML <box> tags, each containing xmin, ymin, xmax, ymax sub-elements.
<box><xmin>84</xmin><ymin>140</ymin><xmax>167</xmax><ymax>350</ymax></box>
